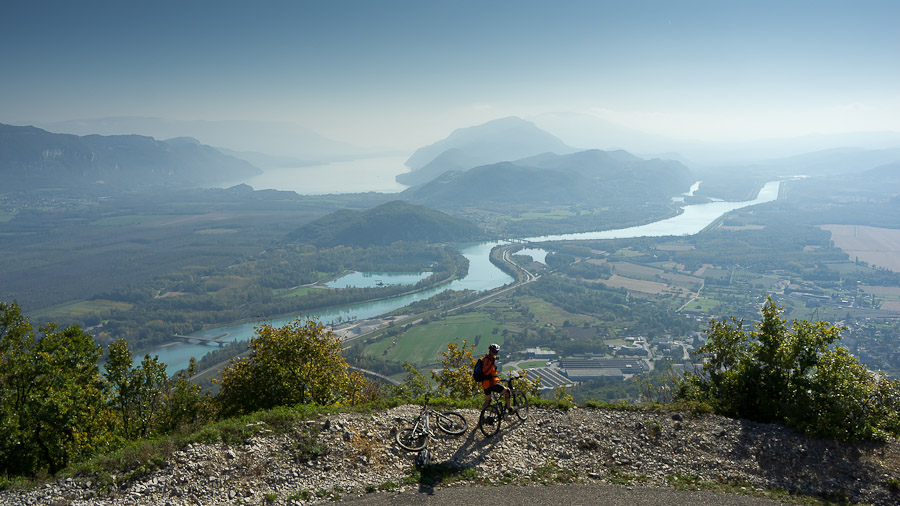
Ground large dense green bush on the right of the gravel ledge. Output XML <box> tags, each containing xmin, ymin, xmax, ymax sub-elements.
<box><xmin>676</xmin><ymin>298</ymin><xmax>900</xmax><ymax>440</ymax></box>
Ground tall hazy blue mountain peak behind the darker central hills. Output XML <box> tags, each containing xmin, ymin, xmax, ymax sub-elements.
<box><xmin>397</xmin><ymin>117</ymin><xmax>577</xmax><ymax>186</ymax></box>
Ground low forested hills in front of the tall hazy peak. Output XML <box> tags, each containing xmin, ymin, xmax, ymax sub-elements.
<box><xmin>401</xmin><ymin>150</ymin><xmax>696</xmax><ymax>209</ymax></box>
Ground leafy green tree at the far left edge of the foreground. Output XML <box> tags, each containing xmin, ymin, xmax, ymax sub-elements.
<box><xmin>0</xmin><ymin>303</ymin><xmax>111</xmax><ymax>475</ymax></box>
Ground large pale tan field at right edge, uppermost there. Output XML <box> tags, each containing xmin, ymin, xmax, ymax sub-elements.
<box><xmin>820</xmin><ymin>225</ymin><xmax>900</xmax><ymax>272</ymax></box>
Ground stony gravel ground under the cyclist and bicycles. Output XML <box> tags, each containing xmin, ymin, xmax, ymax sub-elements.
<box><xmin>0</xmin><ymin>406</ymin><xmax>900</xmax><ymax>506</ymax></box>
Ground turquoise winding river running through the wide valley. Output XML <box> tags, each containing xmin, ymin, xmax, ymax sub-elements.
<box><xmin>150</xmin><ymin>181</ymin><xmax>780</xmax><ymax>372</ymax></box>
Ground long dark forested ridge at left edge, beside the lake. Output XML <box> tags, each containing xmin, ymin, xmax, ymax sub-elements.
<box><xmin>0</xmin><ymin>124</ymin><xmax>260</xmax><ymax>190</ymax></box>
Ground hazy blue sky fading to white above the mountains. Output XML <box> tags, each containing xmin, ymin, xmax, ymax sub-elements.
<box><xmin>0</xmin><ymin>0</ymin><xmax>900</xmax><ymax>148</ymax></box>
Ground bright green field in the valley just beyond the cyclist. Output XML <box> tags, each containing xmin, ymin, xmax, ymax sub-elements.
<box><xmin>365</xmin><ymin>313</ymin><xmax>503</xmax><ymax>366</ymax></box>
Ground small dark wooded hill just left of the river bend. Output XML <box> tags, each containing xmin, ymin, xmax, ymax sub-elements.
<box><xmin>287</xmin><ymin>200</ymin><xmax>485</xmax><ymax>248</ymax></box>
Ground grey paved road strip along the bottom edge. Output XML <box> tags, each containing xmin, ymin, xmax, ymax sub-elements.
<box><xmin>343</xmin><ymin>485</ymin><xmax>786</xmax><ymax>506</ymax></box>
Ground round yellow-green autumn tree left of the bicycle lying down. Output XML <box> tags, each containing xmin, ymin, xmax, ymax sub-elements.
<box><xmin>216</xmin><ymin>319</ymin><xmax>369</xmax><ymax>416</ymax></box>
